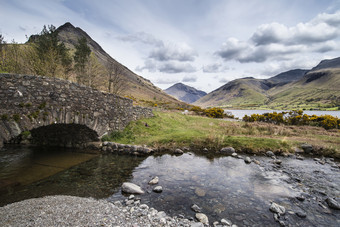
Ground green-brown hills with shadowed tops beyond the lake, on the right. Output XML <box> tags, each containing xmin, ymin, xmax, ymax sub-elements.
<box><xmin>194</xmin><ymin>58</ymin><xmax>340</xmax><ymax>109</ymax></box>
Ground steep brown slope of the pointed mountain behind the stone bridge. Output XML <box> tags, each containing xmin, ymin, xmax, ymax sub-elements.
<box><xmin>57</xmin><ymin>23</ymin><xmax>185</xmax><ymax>106</ymax></box>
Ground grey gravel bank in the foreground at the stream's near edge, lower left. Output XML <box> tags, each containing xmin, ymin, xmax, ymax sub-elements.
<box><xmin>0</xmin><ymin>196</ymin><xmax>199</xmax><ymax>227</ymax></box>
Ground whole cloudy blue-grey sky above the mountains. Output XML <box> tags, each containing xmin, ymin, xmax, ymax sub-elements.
<box><xmin>0</xmin><ymin>0</ymin><xmax>340</xmax><ymax>92</ymax></box>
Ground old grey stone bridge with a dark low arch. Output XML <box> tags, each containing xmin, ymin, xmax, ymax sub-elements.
<box><xmin>0</xmin><ymin>74</ymin><xmax>153</xmax><ymax>147</ymax></box>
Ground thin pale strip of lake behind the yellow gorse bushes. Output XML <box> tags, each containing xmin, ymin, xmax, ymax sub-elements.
<box><xmin>224</xmin><ymin>109</ymin><xmax>340</xmax><ymax>119</ymax></box>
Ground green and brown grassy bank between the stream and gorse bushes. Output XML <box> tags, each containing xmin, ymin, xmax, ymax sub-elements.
<box><xmin>103</xmin><ymin>111</ymin><xmax>340</xmax><ymax>158</ymax></box>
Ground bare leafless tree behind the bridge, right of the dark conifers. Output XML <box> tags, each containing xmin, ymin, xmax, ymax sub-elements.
<box><xmin>107</xmin><ymin>61</ymin><xmax>128</xmax><ymax>95</ymax></box>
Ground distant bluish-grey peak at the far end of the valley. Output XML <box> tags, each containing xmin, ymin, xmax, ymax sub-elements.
<box><xmin>164</xmin><ymin>83</ymin><xmax>207</xmax><ymax>103</ymax></box>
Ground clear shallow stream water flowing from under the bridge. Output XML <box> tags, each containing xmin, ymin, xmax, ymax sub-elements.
<box><xmin>0</xmin><ymin>147</ymin><xmax>340</xmax><ymax>226</ymax></box>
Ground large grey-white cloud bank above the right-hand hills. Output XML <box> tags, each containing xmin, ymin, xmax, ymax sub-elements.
<box><xmin>216</xmin><ymin>12</ymin><xmax>340</xmax><ymax>63</ymax></box>
